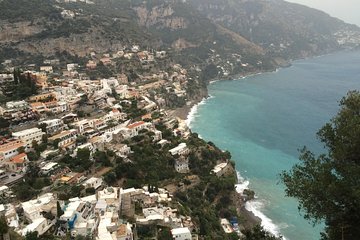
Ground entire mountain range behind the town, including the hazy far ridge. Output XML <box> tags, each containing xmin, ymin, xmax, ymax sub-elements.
<box><xmin>0</xmin><ymin>0</ymin><xmax>360</xmax><ymax>78</ymax></box>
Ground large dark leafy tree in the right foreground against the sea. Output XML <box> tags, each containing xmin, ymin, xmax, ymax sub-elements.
<box><xmin>281</xmin><ymin>91</ymin><xmax>360</xmax><ymax>239</ymax></box>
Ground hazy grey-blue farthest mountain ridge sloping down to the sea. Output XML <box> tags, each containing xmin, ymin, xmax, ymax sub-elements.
<box><xmin>189</xmin><ymin>0</ymin><xmax>360</xmax><ymax>59</ymax></box>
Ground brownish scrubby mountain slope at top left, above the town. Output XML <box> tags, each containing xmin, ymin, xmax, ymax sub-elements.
<box><xmin>0</xmin><ymin>0</ymin><xmax>158</xmax><ymax>62</ymax></box>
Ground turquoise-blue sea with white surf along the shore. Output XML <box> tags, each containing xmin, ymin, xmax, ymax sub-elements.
<box><xmin>188</xmin><ymin>51</ymin><xmax>360</xmax><ymax>240</ymax></box>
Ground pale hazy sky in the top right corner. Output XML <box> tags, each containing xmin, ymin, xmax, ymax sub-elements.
<box><xmin>286</xmin><ymin>0</ymin><xmax>360</xmax><ymax>26</ymax></box>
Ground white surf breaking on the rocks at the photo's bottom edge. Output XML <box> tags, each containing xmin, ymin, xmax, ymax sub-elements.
<box><xmin>245</xmin><ymin>199</ymin><xmax>286</xmax><ymax>240</ymax></box>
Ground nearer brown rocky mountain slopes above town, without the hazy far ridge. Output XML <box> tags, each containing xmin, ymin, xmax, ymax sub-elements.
<box><xmin>0</xmin><ymin>0</ymin><xmax>276</xmax><ymax>73</ymax></box>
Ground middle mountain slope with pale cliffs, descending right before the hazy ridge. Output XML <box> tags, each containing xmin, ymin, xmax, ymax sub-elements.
<box><xmin>133</xmin><ymin>1</ymin><xmax>274</xmax><ymax>69</ymax></box>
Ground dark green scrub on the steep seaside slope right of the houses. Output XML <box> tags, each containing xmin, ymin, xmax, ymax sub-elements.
<box><xmin>170</xmin><ymin>134</ymin><xmax>238</xmax><ymax>239</ymax></box>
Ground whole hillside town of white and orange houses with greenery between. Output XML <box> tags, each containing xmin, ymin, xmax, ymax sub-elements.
<box><xmin>0</xmin><ymin>46</ymin><xmax>241</xmax><ymax>240</ymax></box>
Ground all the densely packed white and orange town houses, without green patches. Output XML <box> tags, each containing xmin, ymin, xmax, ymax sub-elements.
<box><xmin>0</xmin><ymin>44</ymin><xmax>211</xmax><ymax>240</ymax></box>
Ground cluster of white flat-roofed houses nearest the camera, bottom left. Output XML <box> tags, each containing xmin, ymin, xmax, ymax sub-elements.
<box><xmin>0</xmin><ymin>183</ymin><xmax>194</xmax><ymax>240</ymax></box>
